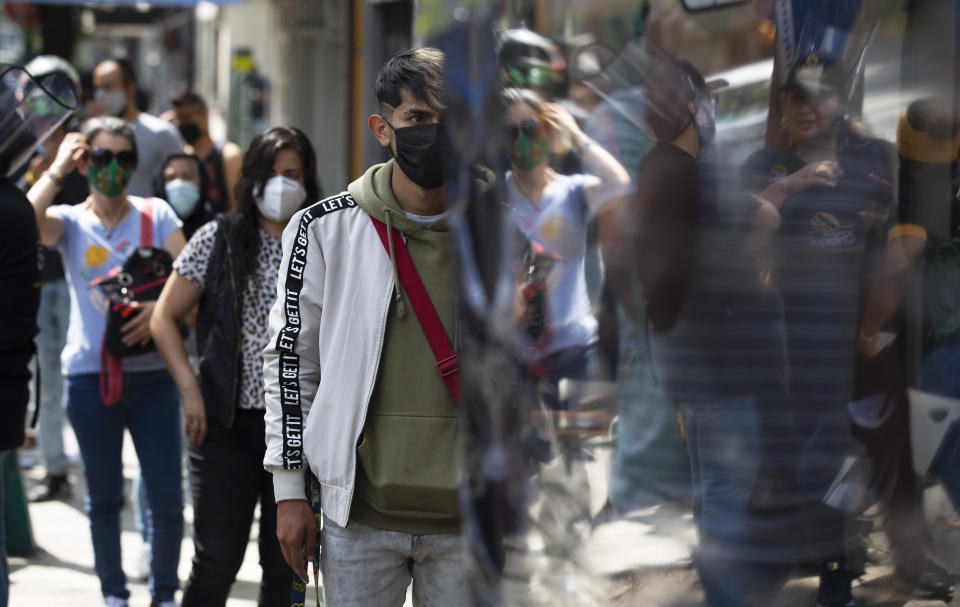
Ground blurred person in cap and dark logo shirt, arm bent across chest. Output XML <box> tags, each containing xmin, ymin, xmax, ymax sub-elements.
<box><xmin>742</xmin><ymin>56</ymin><xmax>916</xmax><ymax>607</ymax></box>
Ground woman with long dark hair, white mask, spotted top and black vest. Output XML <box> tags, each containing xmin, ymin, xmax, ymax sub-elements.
<box><xmin>150</xmin><ymin>127</ymin><xmax>320</xmax><ymax>607</ymax></box>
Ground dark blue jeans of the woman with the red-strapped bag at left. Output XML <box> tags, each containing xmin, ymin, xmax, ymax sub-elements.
<box><xmin>67</xmin><ymin>370</ymin><xmax>183</xmax><ymax>602</ymax></box>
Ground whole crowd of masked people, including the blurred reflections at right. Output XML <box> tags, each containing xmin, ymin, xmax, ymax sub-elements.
<box><xmin>0</xmin><ymin>2</ymin><xmax>960</xmax><ymax>607</ymax></box>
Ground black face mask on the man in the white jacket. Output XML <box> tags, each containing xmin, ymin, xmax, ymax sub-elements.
<box><xmin>383</xmin><ymin>118</ymin><xmax>452</xmax><ymax>190</ymax></box>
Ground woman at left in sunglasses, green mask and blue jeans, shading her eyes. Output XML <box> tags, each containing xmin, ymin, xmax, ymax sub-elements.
<box><xmin>27</xmin><ymin>117</ymin><xmax>184</xmax><ymax>607</ymax></box>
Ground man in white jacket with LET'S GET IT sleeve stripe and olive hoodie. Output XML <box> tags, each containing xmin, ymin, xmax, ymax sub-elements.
<box><xmin>264</xmin><ymin>48</ymin><xmax>470</xmax><ymax>607</ymax></box>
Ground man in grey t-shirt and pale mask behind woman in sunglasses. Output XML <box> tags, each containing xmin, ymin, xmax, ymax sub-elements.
<box><xmin>90</xmin><ymin>59</ymin><xmax>183</xmax><ymax>196</ymax></box>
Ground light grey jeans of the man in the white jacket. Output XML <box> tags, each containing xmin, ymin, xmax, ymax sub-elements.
<box><xmin>320</xmin><ymin>516</ymin><xmax>471</xmax><ymax>607</ymax></box>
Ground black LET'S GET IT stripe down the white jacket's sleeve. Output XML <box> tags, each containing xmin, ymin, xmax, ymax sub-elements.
<box><xmin>276</xmin><ymin>194</ymin><xmax>357</xmax><ymax>470</ymax></box>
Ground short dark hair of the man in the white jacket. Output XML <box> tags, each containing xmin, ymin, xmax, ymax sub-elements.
<box><xmin>375</xmin><ymin>47</ymin><xmax>444</xmax><ymax>110</ymax></box>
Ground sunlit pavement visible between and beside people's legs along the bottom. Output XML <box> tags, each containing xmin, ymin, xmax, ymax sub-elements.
<box><xmin>10</xmin><ymin>428</ymin><xmax>960</xmax><ymax>607</ymax></box>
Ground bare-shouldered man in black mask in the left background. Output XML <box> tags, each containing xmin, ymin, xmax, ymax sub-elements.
<box><xmin>173</xmin><ymin>89</ymin><xmax>243</xmax><ymax>213</ymax></box>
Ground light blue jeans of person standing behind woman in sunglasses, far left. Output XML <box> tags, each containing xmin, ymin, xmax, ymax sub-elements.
<box><xmin>36</xmin><ymin>279</ymin><xmax>70</xmax><ymax>476</ymax></box>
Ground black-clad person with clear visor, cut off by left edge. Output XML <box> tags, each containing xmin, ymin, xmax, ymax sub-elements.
<box><xmin>0</xmin><ymin>66</ymin><xmax>77</xmax><ymax>607</ymax></box>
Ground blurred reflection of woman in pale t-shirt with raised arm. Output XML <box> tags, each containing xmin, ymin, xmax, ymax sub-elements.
<box><xmin>503</xmin><ymin>89</ymin><xmax>630</xmax><ymax>402</ymax></box>
